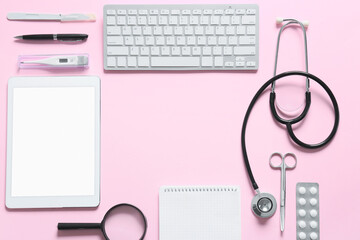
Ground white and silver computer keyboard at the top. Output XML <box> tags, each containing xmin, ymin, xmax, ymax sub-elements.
<box><xmin>104</xmin><ymin>4</ymin><xmax>259</xmax><ymax>70</ymax></box>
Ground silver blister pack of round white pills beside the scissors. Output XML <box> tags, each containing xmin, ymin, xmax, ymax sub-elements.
<box><xmin>296</xmin><ymin>182</ymin><xmax>320</xmax><ymax>240</ymax></box>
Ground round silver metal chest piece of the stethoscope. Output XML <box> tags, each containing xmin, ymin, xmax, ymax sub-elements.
<box><xmin>251</xmin><ymin>193</ymin><xmax>276</xmax><ymax>218</ymax></box>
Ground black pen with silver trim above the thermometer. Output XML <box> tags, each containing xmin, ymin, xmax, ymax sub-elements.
<box><xmin>15</xmin><ymin>34</ymin><xmax>88</xmax><ymax>42</ymax></box>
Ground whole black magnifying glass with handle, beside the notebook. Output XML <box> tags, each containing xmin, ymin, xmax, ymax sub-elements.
<box><xmin>58</xmin><ymin>203</ymin><xmax>147</xmax><ymax>240</ymax></box>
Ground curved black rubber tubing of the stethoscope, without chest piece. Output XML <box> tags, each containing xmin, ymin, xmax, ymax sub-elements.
<box><xmin>241</xmin><ymin>71</ymin><xmax>340</xmax><ymax>191</ymax></box>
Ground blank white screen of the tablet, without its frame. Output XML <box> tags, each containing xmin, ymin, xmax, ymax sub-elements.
<box><xmin>11</xmin><ymin>87</ymin><xmax>95</xmax><ymax>197</ymax></box>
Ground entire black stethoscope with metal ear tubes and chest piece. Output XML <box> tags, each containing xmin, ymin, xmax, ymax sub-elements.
<box><xmin>241</xmin><ymin>19</ymin><xmax>340</xmax><ymax>218</ymax></box>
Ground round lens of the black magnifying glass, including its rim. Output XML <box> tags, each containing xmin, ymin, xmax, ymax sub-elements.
<box><xmin>104</xmin><ymin>206</ymin><xmax>145</xmax><ymax>240</ymax></box>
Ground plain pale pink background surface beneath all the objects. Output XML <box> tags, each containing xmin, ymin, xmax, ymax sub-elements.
<box><xmin>0</xmin><ymin>0</ymin><xmax>360</xmax><ymax>240</ymax></box>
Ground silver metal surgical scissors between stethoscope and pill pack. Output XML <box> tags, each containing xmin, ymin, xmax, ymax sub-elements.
<box><xmin>269</xmin><ymin>152</ymin><xmax>297</xmax><ymax>232</ymax></box>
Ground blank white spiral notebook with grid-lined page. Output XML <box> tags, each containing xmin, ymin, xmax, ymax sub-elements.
<box><xmin>159</xmin><ymin>186</ymin><xmax>241</xmax><ymax>240</ymax></box>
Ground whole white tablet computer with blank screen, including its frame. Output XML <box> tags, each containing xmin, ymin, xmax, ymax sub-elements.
<box><xmin>6</xmin><ymin>76</ymin><xmax>100</xmax><ymax>208</ymax></box>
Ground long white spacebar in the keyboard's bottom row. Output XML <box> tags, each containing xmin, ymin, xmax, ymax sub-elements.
<box><xmin>151</xmin><ymin>57</ymin><xmax>200</xmax><ymax>67</ymax></box>
